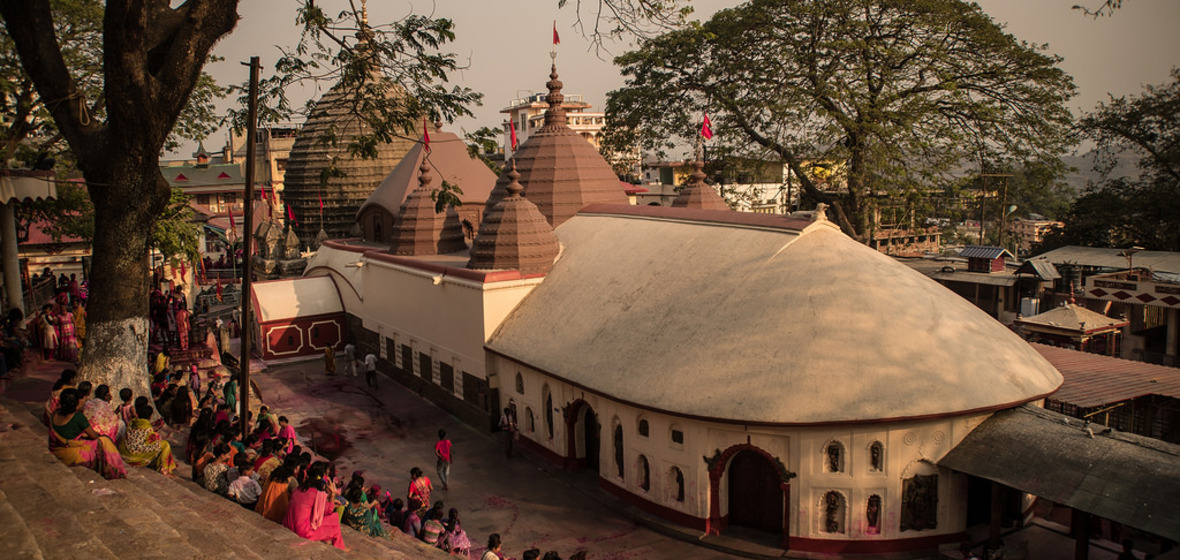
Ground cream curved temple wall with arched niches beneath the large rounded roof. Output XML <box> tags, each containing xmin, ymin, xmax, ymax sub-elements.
<box><xmin>489</xmin><ymin>354</ymin><xmax>989</xmax><ymax>547</ymax></box>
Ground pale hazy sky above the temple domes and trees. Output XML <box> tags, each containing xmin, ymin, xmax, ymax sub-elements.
<box><xmin>182</xmin><ymin>0</ymin><xmax>1180</xmax><ymax>156</ymax></box>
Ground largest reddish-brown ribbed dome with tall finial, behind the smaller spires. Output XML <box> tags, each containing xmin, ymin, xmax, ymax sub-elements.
<box><xmin>486</xmin><ymin>62</ymin><xmax>628</xmax><ymax>229</ymax></box>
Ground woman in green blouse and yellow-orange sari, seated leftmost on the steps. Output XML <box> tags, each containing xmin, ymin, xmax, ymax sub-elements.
<box><xmin>50</xmin><ymin>389</ymin><xmax>127</xmax><ymax>479</ymax></box>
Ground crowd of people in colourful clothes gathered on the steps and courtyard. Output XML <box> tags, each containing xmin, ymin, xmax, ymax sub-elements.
<box><xmin>23</xmin><ymin>269</ymin><xmax>594</xmax><ymax>560</ymax></box>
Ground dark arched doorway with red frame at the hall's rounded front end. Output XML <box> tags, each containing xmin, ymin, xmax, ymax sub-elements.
<box><xmin>729</xmin><ymin>450</ymin><xmax>784</xmax><ymax>535</ymax></box>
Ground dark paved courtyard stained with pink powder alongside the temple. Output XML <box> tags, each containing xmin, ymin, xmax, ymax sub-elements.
<box><xmin>7</xmin><ymin>360</ymin><xmax>1132</xmax><ymax>560</ymax></box>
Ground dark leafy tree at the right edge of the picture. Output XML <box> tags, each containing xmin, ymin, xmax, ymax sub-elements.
<box><xmin>1041</xmin><ymin>70</ymin><xmax>1180</xmax><ymax>251</ymax></box>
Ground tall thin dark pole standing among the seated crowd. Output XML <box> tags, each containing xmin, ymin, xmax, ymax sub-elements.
<box><xmin>238</xmin><ymin>57</ymin><xmax>262</xmax><ymax>440</ymax></box>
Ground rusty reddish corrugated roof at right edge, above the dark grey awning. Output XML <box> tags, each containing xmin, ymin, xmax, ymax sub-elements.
<box><xmin>1033</xmin><ymin>344</ymin><xmax>1180</xmax><ymax>408</ymax></box>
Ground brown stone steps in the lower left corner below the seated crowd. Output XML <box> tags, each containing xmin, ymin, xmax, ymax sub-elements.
<box><xmin>0</xmin><ymin>398</ymin><xmax>454</xmax><ymax>560</ymax></box>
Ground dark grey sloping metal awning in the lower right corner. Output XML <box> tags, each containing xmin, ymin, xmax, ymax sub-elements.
<box><xmin>938</xmin><ymin>406</ymin><xmax>1180</xmax><ymax>540</ymax></box>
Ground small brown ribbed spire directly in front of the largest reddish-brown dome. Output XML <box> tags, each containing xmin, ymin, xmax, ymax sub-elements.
<box><xmin>467</xmin><ymin>163</ymin><xmax>561</xmax><ymax>275</ymax></box>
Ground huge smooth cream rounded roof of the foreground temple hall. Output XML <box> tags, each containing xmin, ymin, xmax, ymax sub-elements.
<box><xmin>487</xmin><ymin>205</ymin><xmax>1062</xmax><ymax>424</ymax></box>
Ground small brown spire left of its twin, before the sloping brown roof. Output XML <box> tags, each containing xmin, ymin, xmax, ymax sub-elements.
<box><xmin>389</xmin><ymin>158</ymin><xmax>467</xmax><ymax>256</ymax></box>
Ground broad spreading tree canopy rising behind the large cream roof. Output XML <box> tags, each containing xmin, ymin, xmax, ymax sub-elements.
<box><xmin>607</xmin><ymin>0</ymin><xmax>1075</xmax><ymax>241</ymax></box>
